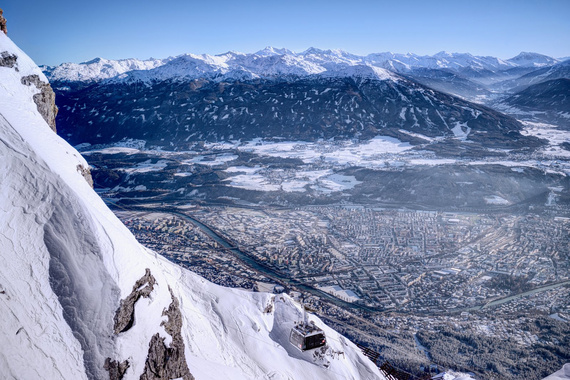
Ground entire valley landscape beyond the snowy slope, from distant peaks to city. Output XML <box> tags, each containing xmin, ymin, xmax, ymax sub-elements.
<box><xmin>36</xmin><ymin>48</ymin><xmax>570</xmax><ymax>379</ymax></box>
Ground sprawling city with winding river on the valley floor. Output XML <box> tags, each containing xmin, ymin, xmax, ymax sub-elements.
<box><xmin>111</xmin><ymin>203</ymin><xmax>570</xmax><ymax>378</ymax></box>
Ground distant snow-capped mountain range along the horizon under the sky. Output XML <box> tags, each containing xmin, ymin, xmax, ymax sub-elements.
<box><xmin>43</xmin><ymin>47</ymin><xmax>559</xmax><ymax>82</ymax></box>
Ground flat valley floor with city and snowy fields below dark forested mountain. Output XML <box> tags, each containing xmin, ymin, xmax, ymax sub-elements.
<box><xmin>79</xmin><ymin>122</ymin><xmax>570</xmax><ymax>379</ymax></box>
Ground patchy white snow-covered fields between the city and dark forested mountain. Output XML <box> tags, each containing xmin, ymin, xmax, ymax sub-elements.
<box><xmin>82</xmin><ymin>122</ymin><xmax>570</xmax><ymax>196</ymax></box>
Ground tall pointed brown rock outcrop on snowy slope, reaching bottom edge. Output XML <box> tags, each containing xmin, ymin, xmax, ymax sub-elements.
<box><xmin>140</xmin><ymin>287</ymin><xmax>194</xmax><ymax>380</ymax></box>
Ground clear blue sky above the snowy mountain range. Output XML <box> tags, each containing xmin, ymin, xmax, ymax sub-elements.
<box><xmin>1</xmin><ymin>0</ymin><xmax>570</xmax><ymax>65</ymax></box>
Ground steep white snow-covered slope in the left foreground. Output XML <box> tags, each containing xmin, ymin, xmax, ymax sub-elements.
<box><xmin>0</xmin><ymin>33</ymin><xmax>383</xmax><ymax>379</ymax></box>
